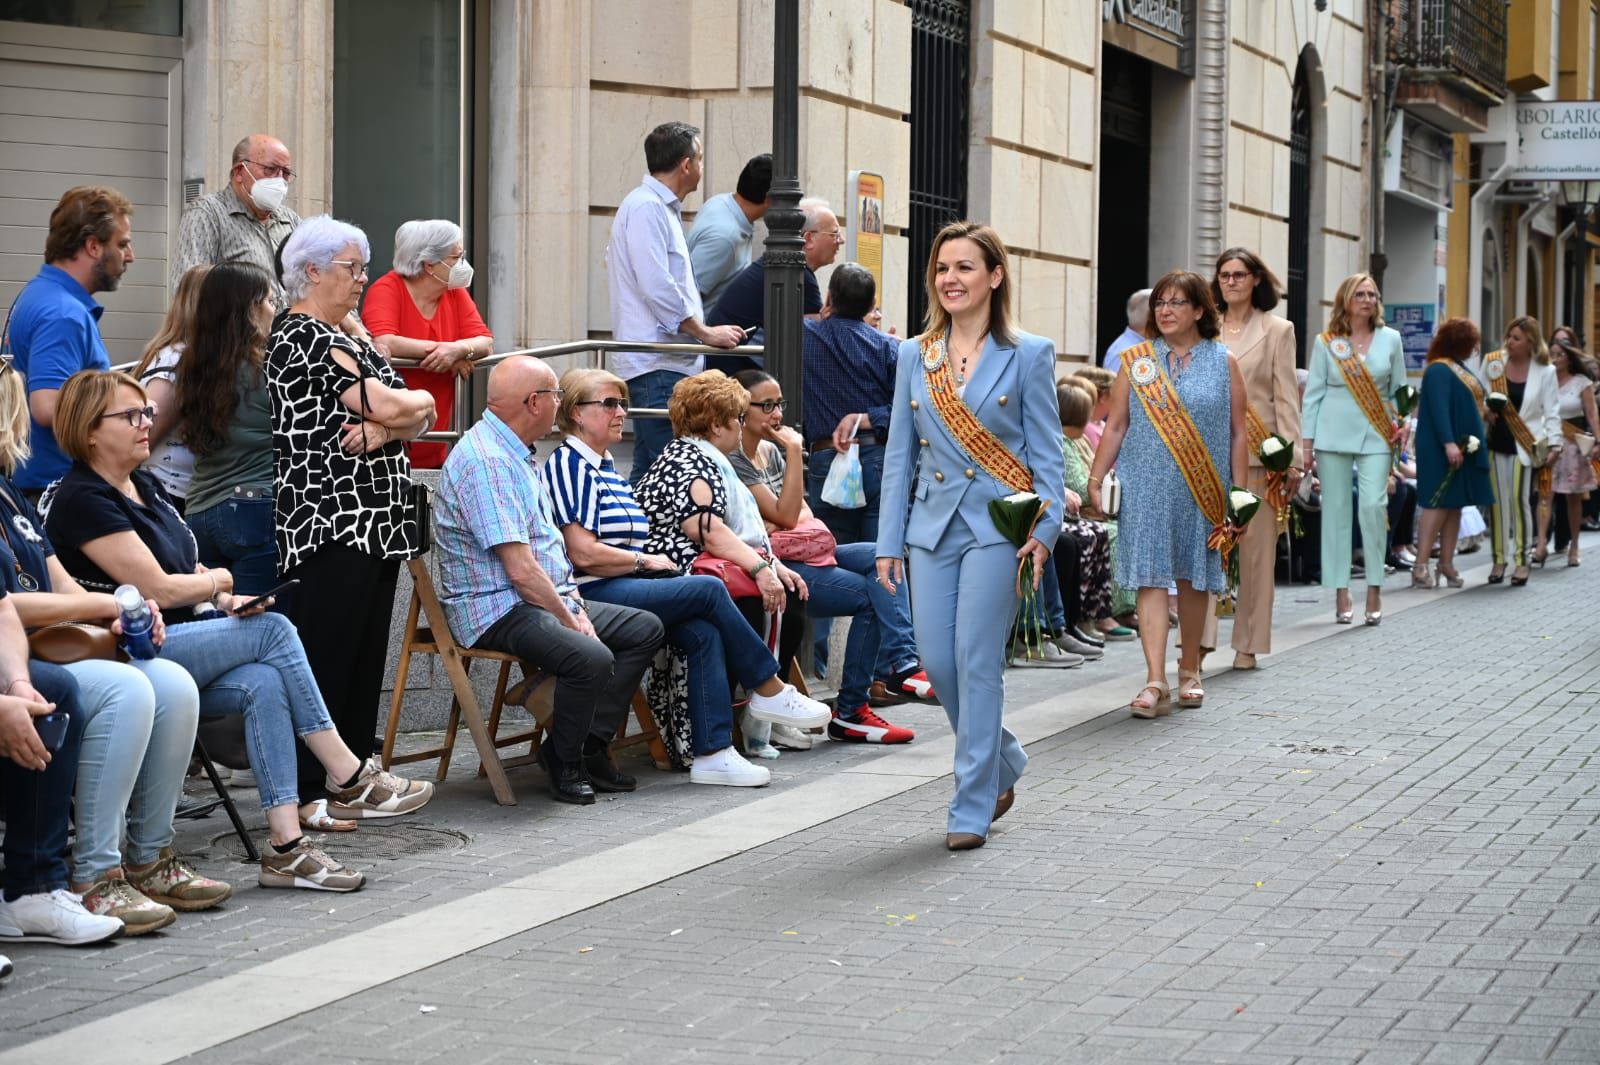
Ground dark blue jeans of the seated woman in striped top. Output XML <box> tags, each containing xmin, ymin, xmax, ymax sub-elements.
<box><xmin>582</xmin><ymin>574</ymin><xmax>778</xmax><ymax>755</ymax></box>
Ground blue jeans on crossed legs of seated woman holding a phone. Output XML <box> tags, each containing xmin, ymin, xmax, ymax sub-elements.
<box><xmin>162</xmin><ymin>614</ymin><xmax>333</xmax><ymax>809</ymax></box>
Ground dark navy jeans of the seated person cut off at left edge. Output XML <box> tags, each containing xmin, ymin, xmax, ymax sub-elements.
<box><xmin>0</xmin><ymin>660</ymin><xmax>83</xmax><ymax>902</ymax></box>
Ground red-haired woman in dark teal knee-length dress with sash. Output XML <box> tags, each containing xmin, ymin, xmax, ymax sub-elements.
<box><xmin>1420</xmin><ymin>318</ymin><xmax>1494</xmax><ymax>588</ymax></box>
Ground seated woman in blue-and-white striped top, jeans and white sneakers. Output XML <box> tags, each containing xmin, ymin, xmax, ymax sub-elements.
<box><xmin>539</xmin><ymin>369</ymin><xmax>825</xmax><ymax>787</ymax></box>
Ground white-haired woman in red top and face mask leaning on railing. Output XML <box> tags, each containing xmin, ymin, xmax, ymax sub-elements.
<box><xmin>362</xmin><ymin>217</ymin><xmax>494</xmax><ymax>470</ymax></box>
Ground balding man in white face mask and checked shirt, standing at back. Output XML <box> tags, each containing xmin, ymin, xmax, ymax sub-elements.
<box><xmin>170</xmin><ymin>133</ymin><xmax>299</xmax><ymax>305</ymax></box>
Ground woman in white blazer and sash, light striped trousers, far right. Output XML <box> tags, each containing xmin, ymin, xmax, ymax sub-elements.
<box><xmin>1469</xmin><ymin>315</ymin><xmax>1563</xmax><ymax>587</ymax></box>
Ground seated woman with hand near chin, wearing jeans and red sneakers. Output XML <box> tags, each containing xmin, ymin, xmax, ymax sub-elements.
<box><xmin>731</xmin><ymin>369</ymin><xmax>915</xmax><ymax>750</ymax></box>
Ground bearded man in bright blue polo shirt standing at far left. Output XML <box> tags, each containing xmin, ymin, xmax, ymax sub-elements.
<box><xmin>6</xmin><ymin>185</ymin><xmax>133</xmax><ymax>496</ymax></box>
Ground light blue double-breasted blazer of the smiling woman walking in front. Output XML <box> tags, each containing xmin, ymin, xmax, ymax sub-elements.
<box><xmin>878</xmin><ymin>333</ymin><xmax>1066</xmax><ymax>558</ymax></box>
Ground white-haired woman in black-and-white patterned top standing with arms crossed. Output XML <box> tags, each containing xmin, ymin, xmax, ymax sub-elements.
<box><xmin>266</xmin><ymin>214</ymin><xmax>434</xmax><ymax>801</ymax></box>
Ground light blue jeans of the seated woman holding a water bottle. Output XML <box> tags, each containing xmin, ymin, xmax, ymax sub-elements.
<box><xmin>66</xmin><ymin>657</ymin><xmax>200</xmax><ymax>883</ymax></box>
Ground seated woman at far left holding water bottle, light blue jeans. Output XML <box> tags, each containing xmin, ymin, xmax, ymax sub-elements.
<box><xmin>0</xmin><ymin>363</ymin><xmax>222</xmax><ymax>935</ymax></box>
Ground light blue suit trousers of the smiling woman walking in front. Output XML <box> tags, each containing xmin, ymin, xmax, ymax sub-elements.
<box><xmin>907</xmin><ymin>518</ymin><xmax>1027</xmax><ymax>836</ymax></box>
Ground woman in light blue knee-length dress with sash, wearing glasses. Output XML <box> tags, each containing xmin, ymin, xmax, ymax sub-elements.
<box><xmin>1088</xmin><ymin>270</ymin><xmax>1248</xmax><ymax>718</ymax></box>
